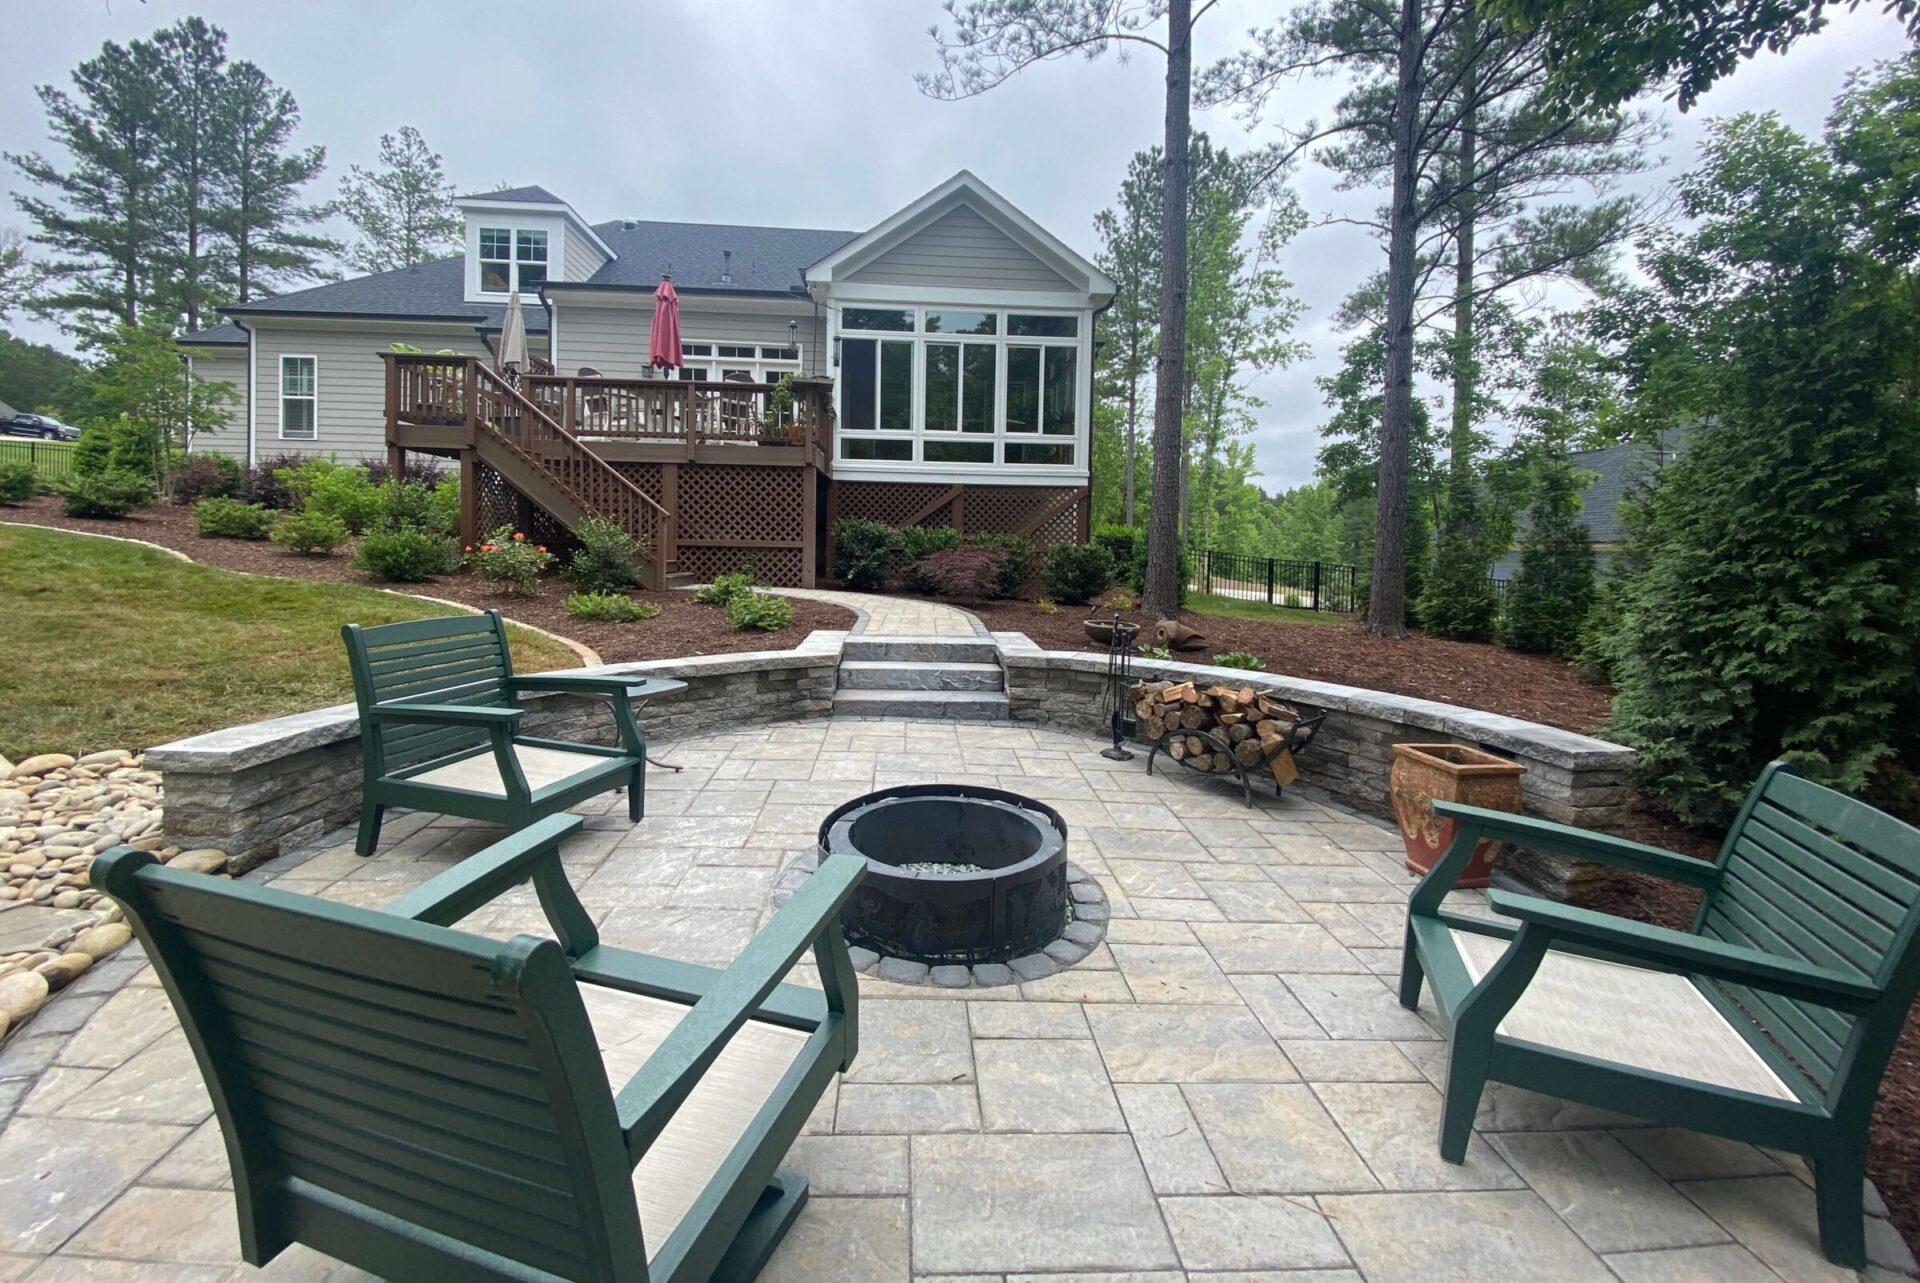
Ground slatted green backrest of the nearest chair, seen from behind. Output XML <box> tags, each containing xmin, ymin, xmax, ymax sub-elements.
<box><xmin>108</xmin><ymin>853</ymin><xmax>645</xmax><ymax>1279</ymax></box>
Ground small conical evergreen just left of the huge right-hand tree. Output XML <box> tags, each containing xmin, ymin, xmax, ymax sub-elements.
<box><xmin>1501</xmin><ymin>448</ymin><xmax>1594</xmax><ymax>659</ymax></box>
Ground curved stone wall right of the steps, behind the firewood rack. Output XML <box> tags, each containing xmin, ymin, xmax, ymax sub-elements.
<box><xmin>996</xmin><ymin>634</ymin><xmax>1634</xmax><ymax>891</ymax></box>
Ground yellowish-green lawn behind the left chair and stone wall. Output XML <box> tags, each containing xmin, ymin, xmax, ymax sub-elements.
<box><xmin>0</xmin><ymin>526</ymin><xmax>580</xmax><ymax>761</ymax></box>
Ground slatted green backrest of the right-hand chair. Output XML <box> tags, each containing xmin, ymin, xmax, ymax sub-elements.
<box><xmin>1695</xmin><ymin>764</ymin><xmax>1920</xmax><ymax>1097</ymax></box>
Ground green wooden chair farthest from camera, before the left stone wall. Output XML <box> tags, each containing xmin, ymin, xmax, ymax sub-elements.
<box><xmin>340</xmin><ymin>611</ymin><xmax>685</xmax><ymax>855</ymax></box>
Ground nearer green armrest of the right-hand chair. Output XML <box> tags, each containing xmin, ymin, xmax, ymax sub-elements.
<box><xmin>1486</xmin><ymin>891</ymin><xmax>1880</xmax><ymax>1014</ymax></box>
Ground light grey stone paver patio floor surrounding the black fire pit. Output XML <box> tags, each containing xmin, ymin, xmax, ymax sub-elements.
<box><xmin>0</xmin><ymin>722</ymin><xmax>1910</xmax><ymax>1283</ymax></box>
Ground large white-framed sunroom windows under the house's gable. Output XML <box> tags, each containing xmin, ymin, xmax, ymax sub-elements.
<box><xmin>829</xmin><ymin>298</ymin><xmax>1092</xmax><ymax>482</ymax></box>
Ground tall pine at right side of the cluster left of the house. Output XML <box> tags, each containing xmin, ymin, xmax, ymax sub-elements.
<box><xmin>215</xmin><ymin>61</ymin><xmax>340</xmax><ymax>303</ymax></box>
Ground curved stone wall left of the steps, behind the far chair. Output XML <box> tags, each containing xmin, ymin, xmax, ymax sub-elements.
<box><xmin>146</xmin><ymin>632</ymin><xmax>843</xmax><ymax>872</ymax></box>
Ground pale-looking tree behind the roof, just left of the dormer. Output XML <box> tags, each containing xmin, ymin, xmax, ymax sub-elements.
<box><xmin>340</xmin><ymin>125</ymin><xmax>467</xmax><ymax>273</ymax></box>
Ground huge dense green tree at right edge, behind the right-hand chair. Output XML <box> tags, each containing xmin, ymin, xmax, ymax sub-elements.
<box><xmin>1613</xmin><ymin>56</ymin><xmax>1920</xmax><ymax>822</ymax></box>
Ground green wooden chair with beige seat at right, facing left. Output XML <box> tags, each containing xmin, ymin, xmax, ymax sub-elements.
<box><xmin>1400</xmin><ymin>763</ymin><xmax>1920</xmax><ymax>1268</ymax></box>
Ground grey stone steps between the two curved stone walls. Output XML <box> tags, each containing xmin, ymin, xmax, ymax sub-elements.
<box><xmin>833</xmin><ymin>634</ymin><xmax>1006</xmax><ymax>722</ymax></box>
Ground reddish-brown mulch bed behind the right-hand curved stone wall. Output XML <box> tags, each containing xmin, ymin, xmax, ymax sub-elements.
<box><xmin>966</xmin><ymin>601</ymin><xmax>1613</xmax><ymax>732</ymax></box>
